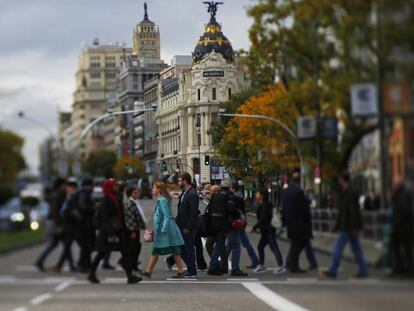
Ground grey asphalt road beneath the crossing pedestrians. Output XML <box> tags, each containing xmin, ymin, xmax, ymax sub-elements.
<box><xmin>0</xmin><ymin>201</ymin><xmax>414</xmax><ymax>311</ymax></box>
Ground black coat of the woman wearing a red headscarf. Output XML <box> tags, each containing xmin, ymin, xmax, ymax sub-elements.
<box><xmin>95</xmin><ymin>195</ymin><xmax>126</xmax><ymax>252</ymax></box>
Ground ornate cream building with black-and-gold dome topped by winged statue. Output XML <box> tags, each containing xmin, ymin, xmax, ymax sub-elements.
<box><xmin>156</xmin><ymin>2</ymin><xmax>248</xmax><ymax>184</ymax></box>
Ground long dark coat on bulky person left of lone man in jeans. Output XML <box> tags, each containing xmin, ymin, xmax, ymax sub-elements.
<box><xmin>282</xmin><ymin>184</ymin><xmax>312</xmax><ymax>240</ymax></box>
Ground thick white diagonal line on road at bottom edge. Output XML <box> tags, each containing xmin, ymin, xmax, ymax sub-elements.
<box><xmin>241</xmin><ymin>282</ymin><xmax>308</xmax><ymax>311</ymax></box>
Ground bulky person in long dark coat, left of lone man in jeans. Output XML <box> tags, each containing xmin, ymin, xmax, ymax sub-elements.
<box><xmin>282</xmin><ymin>172</ymin><xmax>312</xmax><ymax>273</ymax></box>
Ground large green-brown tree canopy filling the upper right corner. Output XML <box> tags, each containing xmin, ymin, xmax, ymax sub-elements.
<box><xmin>212</xmin><ymin>0</ymin><xmax>414</xmax><ymax>183</ymax></box>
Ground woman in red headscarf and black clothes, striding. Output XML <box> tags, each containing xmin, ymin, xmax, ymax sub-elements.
<box><xmin>88</xmin><ymin>179</ymin><xmax>142</xmax><ymax>284</ymax></box>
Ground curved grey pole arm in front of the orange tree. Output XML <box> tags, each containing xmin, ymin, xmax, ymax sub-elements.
<box><xmin>219</xmin><ymin>109</ymin><xmax>305</xmax><ymax>189</ymax></box>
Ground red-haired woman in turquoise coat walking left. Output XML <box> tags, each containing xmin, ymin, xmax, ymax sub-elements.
<box><xmin>141</xmin><ymin>182</ymin><xmax>185</xmax><ymax>278</ymax></box>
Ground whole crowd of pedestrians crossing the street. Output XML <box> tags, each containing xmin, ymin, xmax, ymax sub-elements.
<box><xmin>35</xmin><ymin>172</ymin><xmax>412</xmax><ymax>284</ymax></box>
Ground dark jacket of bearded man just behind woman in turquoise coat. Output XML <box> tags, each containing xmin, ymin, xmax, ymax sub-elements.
<box><xmin>175</xmin><ymin>187</ymin><xmax>200</xmax><ymax>231</ymax></box>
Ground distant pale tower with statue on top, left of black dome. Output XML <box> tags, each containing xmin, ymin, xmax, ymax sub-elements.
<box><xmin>132</xmin><ymin>2</ymin><xmax>161</xmax><ymax>62</ymax></box>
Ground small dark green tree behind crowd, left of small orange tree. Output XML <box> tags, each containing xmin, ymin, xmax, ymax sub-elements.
<box><xmin>82</xmin><ymin>150</ymin><xmax>116</xmax><ymax>178</ymax></box>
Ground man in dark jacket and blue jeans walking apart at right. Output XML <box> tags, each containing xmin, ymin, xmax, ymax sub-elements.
<box><xmin>321</xmin><ymin>172</ymin><xmax>368</xmax><ymax>278</ymax></box>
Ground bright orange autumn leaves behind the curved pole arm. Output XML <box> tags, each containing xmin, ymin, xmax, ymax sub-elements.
<box><xmin>225</xmin><ymin>84</ymin><xmax>299</xmax><ymax>173</ymax></box>
